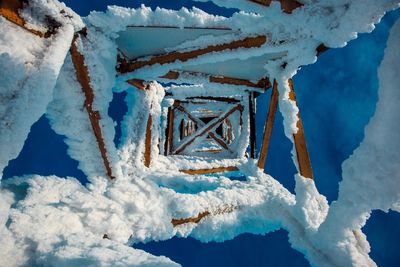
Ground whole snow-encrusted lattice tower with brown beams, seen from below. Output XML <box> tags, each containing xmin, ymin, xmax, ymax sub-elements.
<box><xmin>0</xmin><ymin>0</ymin><xmax>400</xmax><ymax>266</ymax></box>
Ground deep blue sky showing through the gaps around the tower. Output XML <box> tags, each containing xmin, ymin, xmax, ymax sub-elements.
<box><xmin>4</xmin><ymin>0</ymin><xmax>400</xmax><ymax>266</ymax></box>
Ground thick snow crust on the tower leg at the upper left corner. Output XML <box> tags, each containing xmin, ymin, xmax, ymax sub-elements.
<box><xmin>0</xmin><ymin>1</ymin><xmax>83</xmax><ymax>180</ymax></box>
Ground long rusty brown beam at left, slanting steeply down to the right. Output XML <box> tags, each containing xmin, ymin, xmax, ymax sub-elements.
<box><xmin>70</xmin><ymin>34</ymin><xmax>115</xmax><ymax>180</ymax></box>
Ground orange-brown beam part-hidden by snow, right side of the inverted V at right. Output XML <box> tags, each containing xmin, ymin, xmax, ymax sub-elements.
<box><xmin>288</xmin><ymin>79</ymin><xmax>314</xmax><ymax>179</ymax></box>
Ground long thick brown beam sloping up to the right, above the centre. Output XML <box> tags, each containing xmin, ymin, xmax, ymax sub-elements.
<box><xmin>117</xmin><ymin>35</ymin><xmax>267</xmax><ymax>73</ymax></box>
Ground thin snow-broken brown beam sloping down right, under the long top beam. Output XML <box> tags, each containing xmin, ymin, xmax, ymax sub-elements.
<box><xmin>160</xmin><ymin>71</ymin><xmax>271</xmax><ymax>90</ymax></box>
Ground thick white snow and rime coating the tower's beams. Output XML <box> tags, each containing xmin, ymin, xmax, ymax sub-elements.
<box><xmin>0</xmin><ymin>0</ymin><xmax>400</xmax><ymax>266</ymax></box>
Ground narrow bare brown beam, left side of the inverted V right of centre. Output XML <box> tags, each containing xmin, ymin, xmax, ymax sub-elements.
<box><xmin>258</xmin><ymin>80</ymin><xmax>279</xmax><ymax>169</ymax></box>
